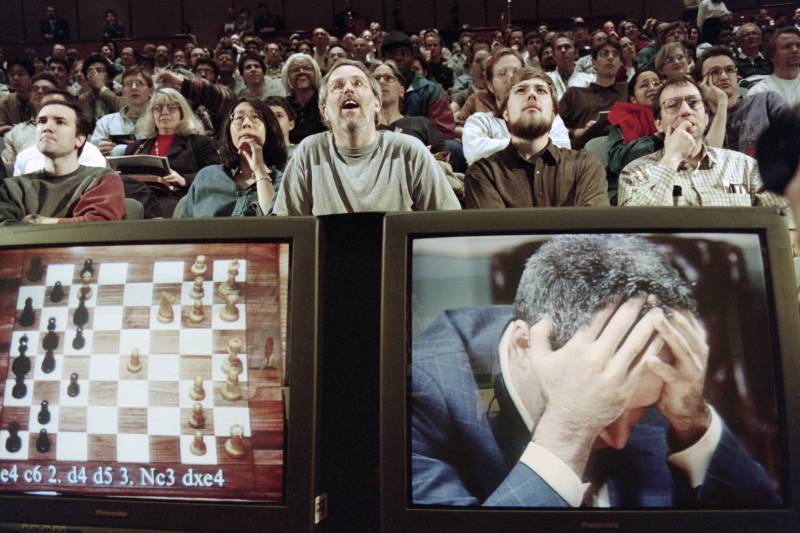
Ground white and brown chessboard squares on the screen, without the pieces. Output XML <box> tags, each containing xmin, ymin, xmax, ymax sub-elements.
<box><xmin>0</xmin><ymin>257</ymin><xmax>253</xmax><ymax>465</ymax></box>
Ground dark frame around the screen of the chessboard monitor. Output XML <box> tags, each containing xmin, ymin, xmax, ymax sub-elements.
<box><xmin>0</xmin><ymin>217</ymin><xmax>318</xmax><ymax>531</ymax></box>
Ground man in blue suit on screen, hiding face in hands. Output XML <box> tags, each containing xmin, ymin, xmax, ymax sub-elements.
<box><xmin>411</xmin><ymin>235</ymin><xmax>780</xmax><ymax>508</ymax></box>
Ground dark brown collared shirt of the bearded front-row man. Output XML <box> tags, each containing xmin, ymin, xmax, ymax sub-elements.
<box><xmin>464</xmin><ymin>142</ymin><xmax>609</xmax><ymax>209</ymax></box>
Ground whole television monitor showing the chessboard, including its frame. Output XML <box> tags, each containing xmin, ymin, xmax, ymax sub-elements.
<box><xmin>0</xmin><ymin>219</ymin><xmax>317</xmax><ymax>531</ymax></box>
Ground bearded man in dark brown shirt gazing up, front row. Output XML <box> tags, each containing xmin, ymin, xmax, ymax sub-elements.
<box><xmin>464</xmin><ymin>67</ymin><xmax>609</xmax><ymax>209</ymax></box>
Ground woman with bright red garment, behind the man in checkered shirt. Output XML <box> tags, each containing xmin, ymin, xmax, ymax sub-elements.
<box><xmin>606</xmin><ymin>70</ymin><xmax>664</xmax><ymax>205</ymax></box>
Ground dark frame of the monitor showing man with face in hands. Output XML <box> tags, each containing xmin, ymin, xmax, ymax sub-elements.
<box><xmin>380</xmin><ymin>208</ymin><xmax>800</xmax><ymax>533</ymax></box>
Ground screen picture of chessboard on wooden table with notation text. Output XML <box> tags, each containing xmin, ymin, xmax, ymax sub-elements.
<box><xmin>0</xmin><ymin>243</ymin><xmax>289</xmax><ymax>502</ymax></box>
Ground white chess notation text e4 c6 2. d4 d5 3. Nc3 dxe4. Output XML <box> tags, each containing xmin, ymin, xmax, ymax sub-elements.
<box><xmin>0</xmin><ymin>465</ymin><xmax>225</xmax><ymax>488</ymax></box>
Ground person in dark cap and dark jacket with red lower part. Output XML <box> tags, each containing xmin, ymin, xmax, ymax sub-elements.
<box><xmin>383</xmin><ymin>31</ymin><xmax>455</xmax><ymax>139</ymax></box>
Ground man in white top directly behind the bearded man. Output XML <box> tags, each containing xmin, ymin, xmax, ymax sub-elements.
<box><xmin>461</xmin><ymin>48</ymin><xmax>571</xmax><ymax>165</ymax></box>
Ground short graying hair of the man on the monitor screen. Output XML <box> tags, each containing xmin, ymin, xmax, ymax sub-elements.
<box><xmin>514</xmin><ymin>234</ymin><xmax>697</xmax><ymax>350</ymax></box>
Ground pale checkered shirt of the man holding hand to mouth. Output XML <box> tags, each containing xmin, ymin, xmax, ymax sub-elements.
<box><xmin>619</xmin><ymin>146</ymin><xmax>788</xmax><ymax>218</ymax></box>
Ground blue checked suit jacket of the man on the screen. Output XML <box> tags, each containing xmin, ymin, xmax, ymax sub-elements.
<box><xmin>411</xmin><ymin>306</ymin><xmax>780</xmax><ymax>508</ymax></box>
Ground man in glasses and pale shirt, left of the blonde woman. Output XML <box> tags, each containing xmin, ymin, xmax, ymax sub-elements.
<box><xmin>91</xmin><ymin>67</ymin><xmax>153</xmax><ymax>156</ymax></box>
